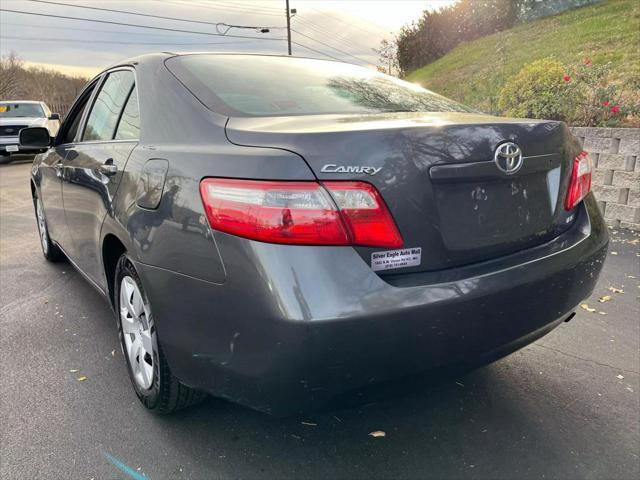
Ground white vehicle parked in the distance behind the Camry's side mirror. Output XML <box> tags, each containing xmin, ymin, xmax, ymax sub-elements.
<box><xmin>0</xmin><ymin>100</ymin><xmax>60</xmax><ymax>162</ymax></box>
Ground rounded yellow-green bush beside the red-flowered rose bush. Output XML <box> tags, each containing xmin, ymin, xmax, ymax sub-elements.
<box><xmin>498</xmin><ymin>58</ymin><xmax>576</xmax><ymax>120</ymax></box>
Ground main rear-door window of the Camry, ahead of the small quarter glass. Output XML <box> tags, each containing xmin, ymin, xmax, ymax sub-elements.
<box><xmin>82</xmin><ymin>70</ymin><xmax>135</xmax><ymax>142</ymax></box>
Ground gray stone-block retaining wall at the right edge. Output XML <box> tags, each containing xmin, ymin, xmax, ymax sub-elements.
<box><xmin>571</xmin><ymin>127</ymin><xmax>640</xmax><ymax>231</ymax></box>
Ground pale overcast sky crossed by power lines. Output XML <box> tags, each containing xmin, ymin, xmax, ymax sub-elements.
<box><xmin>0</xmin><ymin>0</ymin><xmax>454</xmax><ymax>74</ymax></box>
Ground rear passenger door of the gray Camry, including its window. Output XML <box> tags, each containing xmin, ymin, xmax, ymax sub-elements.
<box><xmin>62</xmin><ymin>68</ymin><xmax>140</xmax><ymax>286</ymax></box>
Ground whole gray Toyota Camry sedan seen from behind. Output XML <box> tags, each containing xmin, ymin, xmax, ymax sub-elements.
<box><xmin>20</xmin><ymin>53</ymin><xmax>608</xmax><ymax>415</ymax></box>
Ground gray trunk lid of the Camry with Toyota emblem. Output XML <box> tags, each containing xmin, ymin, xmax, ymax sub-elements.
<box><xmin>226</xmin><ymin>113</ymin><xmax>575</xmax><ymax>273</ymax></box>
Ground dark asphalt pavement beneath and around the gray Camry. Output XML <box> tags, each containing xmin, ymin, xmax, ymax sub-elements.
<box><xmin>0</xmin><ymin>163</ymin><xmax>640</xmax><ymax>480</ymax></box>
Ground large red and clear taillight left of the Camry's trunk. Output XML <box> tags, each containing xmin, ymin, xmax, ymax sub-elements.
<box><xmin>200</xmin><ymin>178</ymin><xmax>402</xmax><ymax>247</ymax></box>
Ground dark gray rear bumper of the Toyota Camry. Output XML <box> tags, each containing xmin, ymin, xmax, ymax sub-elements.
<box><xmin>137</xmin><ymin>196</ymin><xmax>608</xmax><ymax>415</ymax></box>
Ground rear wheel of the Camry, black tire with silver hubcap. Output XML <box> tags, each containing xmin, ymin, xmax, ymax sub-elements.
<box><xmin>114</xmin><ymin>253</ymin><xmax>206</xmax><ymax>415</ymax></box>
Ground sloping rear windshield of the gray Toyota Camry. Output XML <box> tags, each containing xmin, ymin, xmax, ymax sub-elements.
<box><xmin>166</xmin><ymin>54</ymin><xmax>472</xmax><ymax>117</ymax></box>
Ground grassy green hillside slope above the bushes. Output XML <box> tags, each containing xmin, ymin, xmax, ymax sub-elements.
<box><xmin>407</xmin><ymin>0</ymin><xmax>640</xmax><ymax>112</ymax></box>
